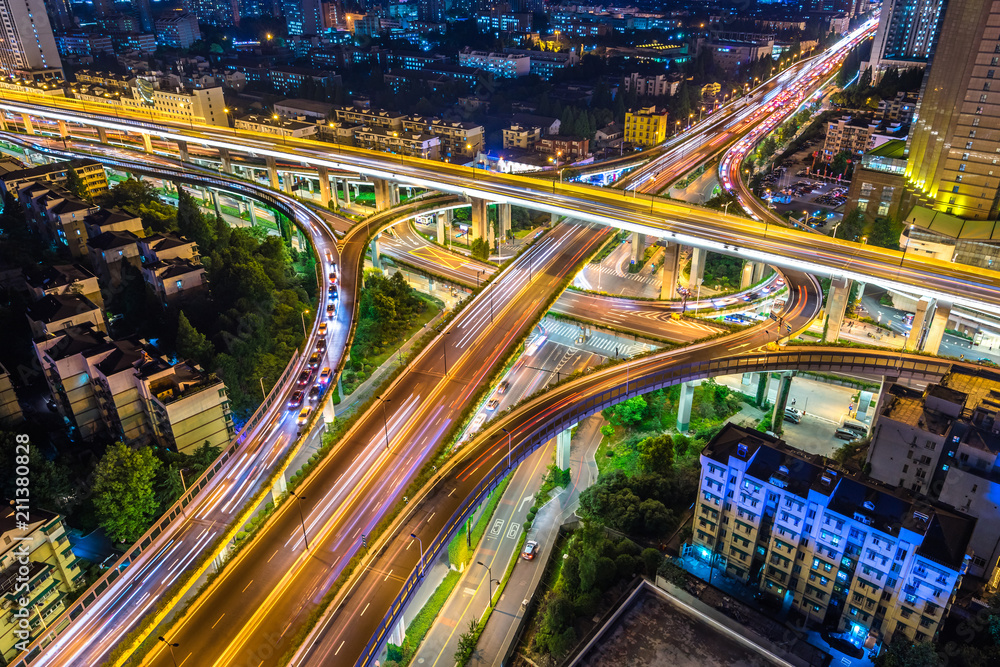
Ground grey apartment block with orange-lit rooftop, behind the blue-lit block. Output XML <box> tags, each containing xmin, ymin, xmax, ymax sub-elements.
<box><xmin>867</xmin><ymin>366</ymin><xmax>1000</xmax><ymax>586</ymax></box>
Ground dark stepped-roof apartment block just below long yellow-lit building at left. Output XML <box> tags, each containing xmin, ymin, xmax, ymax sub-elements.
<box><xmin>17</xmin><ymin>182</ymin><xmax>98</xmax><ymax>257</ymax></box>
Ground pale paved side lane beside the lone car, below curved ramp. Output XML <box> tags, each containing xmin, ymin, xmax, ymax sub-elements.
<box><xmin>469</xmin><ymin>415</ymin><xmax>604</xmax><ymax>667</ymax></box>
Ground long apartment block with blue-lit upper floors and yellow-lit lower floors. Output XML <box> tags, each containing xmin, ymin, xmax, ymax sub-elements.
<box><xmin>689</xmin><ymin>424</ymin><xmax>976</xmax><ymax>648</ymax></box>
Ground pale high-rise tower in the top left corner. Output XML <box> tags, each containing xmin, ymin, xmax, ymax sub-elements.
<box><xmin>0</xmin><ymin>0</ymin><xmax>62</xmax><ymax>74</ymax></box>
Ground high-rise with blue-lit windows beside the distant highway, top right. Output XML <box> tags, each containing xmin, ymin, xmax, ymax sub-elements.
<box><xmin>870</xmin><ymin>0</ymin><xmax>946</xmax><ymax>78</ymax></box>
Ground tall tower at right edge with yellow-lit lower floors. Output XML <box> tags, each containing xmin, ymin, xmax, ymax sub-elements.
<box><xmin>906</xmin><ymin>0</ymin><xmax>1000</xmax><ymax>220</ymax></box>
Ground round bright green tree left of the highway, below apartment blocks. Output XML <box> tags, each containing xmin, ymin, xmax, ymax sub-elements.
<box><xmin>93</xmin><ymin>442</ymin><xmax>160</xmax><ymax>543</ymax></box>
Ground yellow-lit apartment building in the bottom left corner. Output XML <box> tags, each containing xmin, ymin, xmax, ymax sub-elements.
<box><xmin>0</xmin><ymin>506</ymin><xmax>84</xmax><ymax>664</ymax></box>
